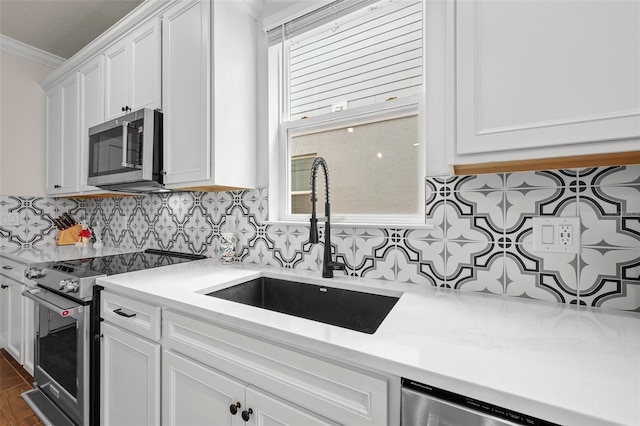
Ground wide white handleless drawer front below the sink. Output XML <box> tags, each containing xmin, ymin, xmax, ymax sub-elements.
<box><xmin>163</xmin><ymin>311</ymin><xmax>388</xmax><ymax>425</ymax></box>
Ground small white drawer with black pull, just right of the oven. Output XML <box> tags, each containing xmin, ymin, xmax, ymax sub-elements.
<box><xmin>100</xmin><ymin>292</ymin><xmax>160</xmax><ymax>341</ymax></box>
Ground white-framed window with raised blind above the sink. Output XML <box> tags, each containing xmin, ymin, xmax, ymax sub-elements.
<box><xmin>269</xmin><ymin>0</ymin><xmax>425</xmax><ymax>223</ymax></box>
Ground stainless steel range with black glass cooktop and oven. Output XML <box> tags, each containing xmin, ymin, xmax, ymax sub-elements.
<box><xmin>22</xmin><ymin>250</ymin><xmax>205</xmax><ymax>426</ymax></box>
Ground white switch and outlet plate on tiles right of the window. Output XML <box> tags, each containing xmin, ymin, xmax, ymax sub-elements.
<box><xmin>533</xmin><ymin>216</ymin><xmax>580</xmax><ymax>253</ymax></box>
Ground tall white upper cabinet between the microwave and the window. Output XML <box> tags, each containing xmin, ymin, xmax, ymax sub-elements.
<box><xmin>162</xmin><ymin>1</ymin><xmax>257</xmax><ymax>190</ymax></box>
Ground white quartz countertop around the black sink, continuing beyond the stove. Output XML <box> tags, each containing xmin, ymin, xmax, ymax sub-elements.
<box><xmin>0</xmin><ymin>247</ymin><xmax>640</xmax><ymax>426</ymax></box>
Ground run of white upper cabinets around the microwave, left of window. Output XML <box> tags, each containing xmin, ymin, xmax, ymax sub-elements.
<box><xmin>41</xmin><ymin>0</ymin><xmax>258</xmax><ymax>196</ymax></box>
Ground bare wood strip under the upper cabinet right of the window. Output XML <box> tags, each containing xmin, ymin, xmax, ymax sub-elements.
<box><xmin>452</xmin><ymin>151</ymin><xmax>640</xmax><ymax>176</ymax></box>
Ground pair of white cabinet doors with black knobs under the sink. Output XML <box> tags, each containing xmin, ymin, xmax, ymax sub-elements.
<box><xmin>162</xmin><ymin>350</ymin><xmax>337</xmax><ymax>426</ymax></box>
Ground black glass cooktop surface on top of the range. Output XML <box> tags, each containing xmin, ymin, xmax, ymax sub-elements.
<box><xmin>46</xmin><ymin>249</ymin><xmax>206</xmax><ymax>278</ymax></box>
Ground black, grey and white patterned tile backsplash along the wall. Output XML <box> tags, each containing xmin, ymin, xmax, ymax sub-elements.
<box><xmin>0</xmin><ymin>165</ymin><xmax>640</xmax><ymax>312</ymax></box>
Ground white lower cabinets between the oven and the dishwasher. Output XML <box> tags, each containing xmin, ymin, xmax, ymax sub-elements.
<box><xmin>100</xmin><ymin>291</ymin><xmax>395</xmax><ymax>426</ymax></box>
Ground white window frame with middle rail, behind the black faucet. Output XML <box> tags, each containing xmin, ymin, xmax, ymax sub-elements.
<box><xmin>267</xmin><ymin>0</ymin><xmax>427</xmax><ymax>227</ymax></box>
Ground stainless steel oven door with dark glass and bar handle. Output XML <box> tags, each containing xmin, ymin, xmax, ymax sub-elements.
<box><xmin>23</xmin><ymin>288</ymin><xmax>91</xmax><ymax>424</ymax></box>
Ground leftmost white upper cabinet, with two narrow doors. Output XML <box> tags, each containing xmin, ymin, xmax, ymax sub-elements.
<box><xmin>45</xmin><ymin>72</ymin><xmax>79</xmax><ymax>195</ymax></box>
